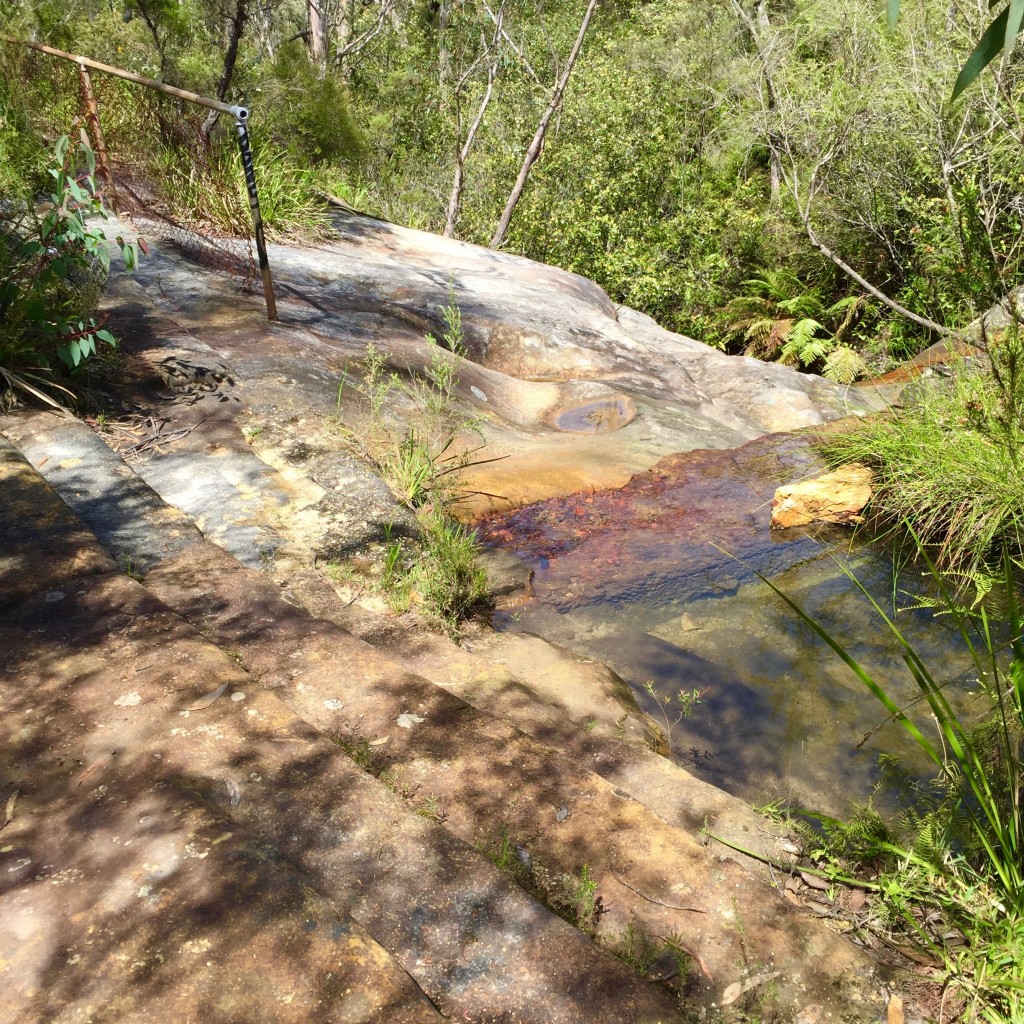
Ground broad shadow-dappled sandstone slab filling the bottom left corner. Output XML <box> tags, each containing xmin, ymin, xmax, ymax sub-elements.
<box><xmin>0</xmin><ymin>439</ymin><xmax>677</xmax><ymax>1024</ymax></box>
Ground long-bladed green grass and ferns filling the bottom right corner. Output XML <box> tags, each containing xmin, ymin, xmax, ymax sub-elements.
<box><xmin>762</xmin><ymin>538</ymin><xmax>1024</xmax><ymax>1022</ymax></box>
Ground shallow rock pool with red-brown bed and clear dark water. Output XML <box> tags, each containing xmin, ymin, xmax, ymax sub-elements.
<box><xmin>481</xmin><ymin>434</ymin><xmax>974</xmax><ymax>813</ymax></box>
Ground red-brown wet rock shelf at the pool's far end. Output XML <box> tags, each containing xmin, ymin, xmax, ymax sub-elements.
<box><xmin>480</xmin><ymin>425</ymin><xmax>824</xmax><ymax>611</ymax></box>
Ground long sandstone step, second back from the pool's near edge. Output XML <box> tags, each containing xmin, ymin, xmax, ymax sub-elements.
<box><xmin>145</xmin><ymin>545</ymin><xmax>880</xmax><ymax>1020</ymax></box>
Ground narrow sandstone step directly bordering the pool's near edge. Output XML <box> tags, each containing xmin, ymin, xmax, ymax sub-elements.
<box><xmin>288</xmin><ymin>578</ymin><xmax>785</xmax><ymax>847</ymax></box>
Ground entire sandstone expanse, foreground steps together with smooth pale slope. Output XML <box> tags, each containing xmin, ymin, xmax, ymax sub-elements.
<box><xmin>0</xmin><ymin>216</ymin><xmax>913</xmax><ymax>1024</ymax></box>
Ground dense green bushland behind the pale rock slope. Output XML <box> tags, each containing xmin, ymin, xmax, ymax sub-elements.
<box><xmin>6</xmin><ymin>0</ymin><xmax>1024</xmax><ymax>378</ymax></box>
